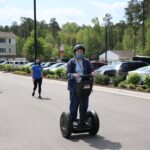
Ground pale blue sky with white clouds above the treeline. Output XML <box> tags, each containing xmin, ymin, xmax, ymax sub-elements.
<box><xmin>0</xmin><ymin>0</ymin><xmax>129</xmax><ymax>26</ymax></box>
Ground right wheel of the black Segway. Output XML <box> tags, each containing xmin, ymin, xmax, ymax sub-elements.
<box><xmin>87</xmin><ymin>110</ymin><xmax>100</xmax><ymax>135</ymax></box>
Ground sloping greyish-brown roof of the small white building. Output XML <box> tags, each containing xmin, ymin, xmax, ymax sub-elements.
<box><xmin>111</xmin><ymin>50</ymin><xmax>134</xmax><ymax>58</ymax></box>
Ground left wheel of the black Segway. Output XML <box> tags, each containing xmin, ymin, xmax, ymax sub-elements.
<box><xmin>60</xmin><ymin>112</ymin><xmax>73</xmax><ymax>138</ymax></box>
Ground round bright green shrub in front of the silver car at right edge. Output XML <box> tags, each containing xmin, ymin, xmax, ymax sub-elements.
<box><xmin>127</xmin><ymin>73</ymin><xmax>141</xmax><ymax>85</ymax></box>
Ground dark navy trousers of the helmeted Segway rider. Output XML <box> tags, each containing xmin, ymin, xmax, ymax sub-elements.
<box><xmin>70</xmin><ymin>91</ymin><xmax>89</xmax><ymax>121</ymax></box>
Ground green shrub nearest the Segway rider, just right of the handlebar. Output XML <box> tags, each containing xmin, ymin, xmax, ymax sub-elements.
<box><xmin>95</xmin><ymin>75</ymin><xmax>109</xmax><ymax>85</ymax></box>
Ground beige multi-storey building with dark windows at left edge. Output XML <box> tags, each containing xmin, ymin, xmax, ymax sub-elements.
<box><xmin>0</xmin><ymin>32</ymin><xmax>17</xmax><ymax>60</ymax></box>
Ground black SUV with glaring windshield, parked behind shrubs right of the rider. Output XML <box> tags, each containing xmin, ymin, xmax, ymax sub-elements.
<box><xmin>100</xmin><ymin>61</ymin><xmax>148</xmax><ymax>77</ymax></box>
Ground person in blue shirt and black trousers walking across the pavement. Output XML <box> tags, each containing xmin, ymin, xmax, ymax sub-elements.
<box><xmin>32</xmin><ymin>60</ymin><xmax>42</xmax><ymax>99</ymax></box>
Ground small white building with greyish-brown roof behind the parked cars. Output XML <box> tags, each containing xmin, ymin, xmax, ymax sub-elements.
<box><xmin>99</xmin><ymin>50</ymin><xmax>134</xmax><ymax>61</ymax></box>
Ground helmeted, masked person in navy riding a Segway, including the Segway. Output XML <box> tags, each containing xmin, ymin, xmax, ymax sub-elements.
<box><xmin>60</xmin><ymin>44</ymin><xmax>99</xmax><ymax>137</ymax></box>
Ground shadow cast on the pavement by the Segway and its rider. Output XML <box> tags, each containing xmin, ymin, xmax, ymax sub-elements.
<box><xmin>70</xmin><ymin>134</ymin><xmax>121</xmax><ymax>150</ymax></box>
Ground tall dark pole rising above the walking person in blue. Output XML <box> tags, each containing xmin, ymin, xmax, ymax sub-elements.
<box><xmin>34</xmin><ymin>0</ymin><xmax>37</xmax><ymax>62</ymax></box>
